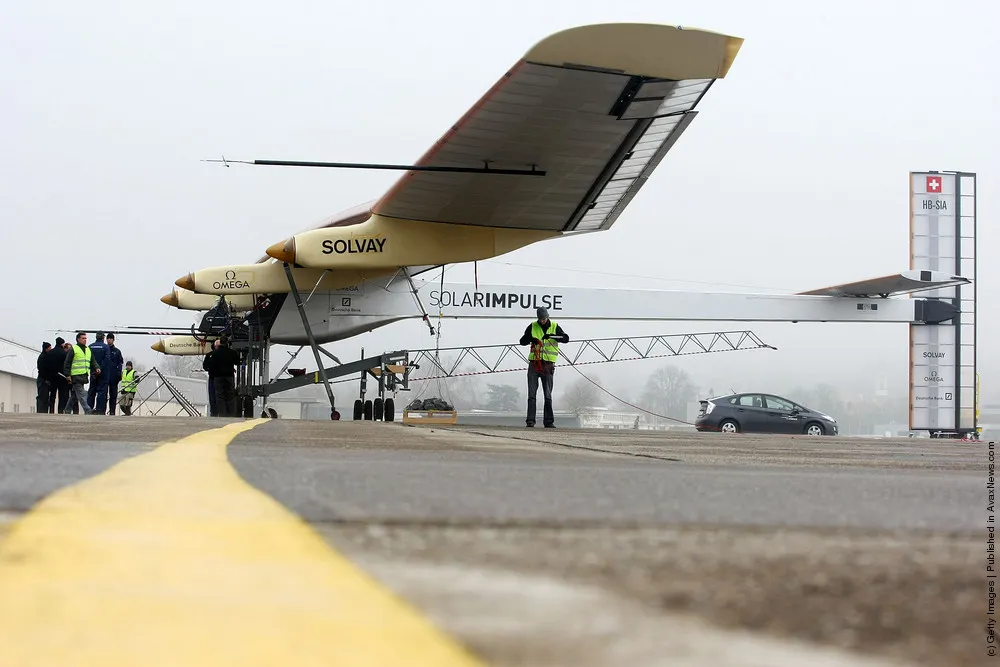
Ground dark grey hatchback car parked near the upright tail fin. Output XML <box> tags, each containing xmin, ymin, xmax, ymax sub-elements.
<box><xmin>695</xmin><ymin>393</ymin><xmax>837</xmax><ymax>435</ymax></box>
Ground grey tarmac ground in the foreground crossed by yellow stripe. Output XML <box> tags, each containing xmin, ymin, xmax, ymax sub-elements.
<box><xmin>0</xmin><ymin>414</ymin><xmax>995</xmax><ymax>667</ymax></box>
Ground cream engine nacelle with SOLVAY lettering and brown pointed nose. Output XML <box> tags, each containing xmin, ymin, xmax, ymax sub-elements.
<box><xmin>267</xmin><ymin>215</ymin><xmax>560</xmax><ymax>271</ymax></box>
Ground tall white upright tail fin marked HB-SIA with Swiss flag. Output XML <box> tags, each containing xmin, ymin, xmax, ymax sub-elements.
<box><xmin>910</xmin><ymin>171</ymin><xmax>978</xmax><ymax>437</ymax></box>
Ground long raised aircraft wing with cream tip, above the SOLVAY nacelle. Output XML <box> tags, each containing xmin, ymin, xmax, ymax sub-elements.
<box><xmin>372</xmin><ymin>24</ymin><xmax>743</xmax><ymax>232</ymax></box>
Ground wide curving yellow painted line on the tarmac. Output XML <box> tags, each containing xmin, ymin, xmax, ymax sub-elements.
<box><xmin>0</xmin><ymin>419</ymin><xmax>481</xmax><ymax>667</ymax></box>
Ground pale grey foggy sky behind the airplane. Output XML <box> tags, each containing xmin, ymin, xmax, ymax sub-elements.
<box><xmin>0</xmin><ymin>0</ymin><xmax>1000</xmax><ymax>397</ymax></box>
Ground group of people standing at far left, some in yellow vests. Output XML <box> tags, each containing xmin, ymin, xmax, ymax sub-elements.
<box><xmin>36</xmin><ymin>331</ymin><xmax>138</xmax><ymax>416</ymax></box>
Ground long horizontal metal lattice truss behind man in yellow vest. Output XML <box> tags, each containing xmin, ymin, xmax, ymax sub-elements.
<box><xmin>410</xmin><ymin>331</ymin><xmax>777</xmax><ymax>381</ymax></box>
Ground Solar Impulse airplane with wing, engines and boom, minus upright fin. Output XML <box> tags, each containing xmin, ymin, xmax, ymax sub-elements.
<box><xmin>137</xmin><ymin>23</ymin><xmax>969</xmax><ymax>422</ymax></box>
